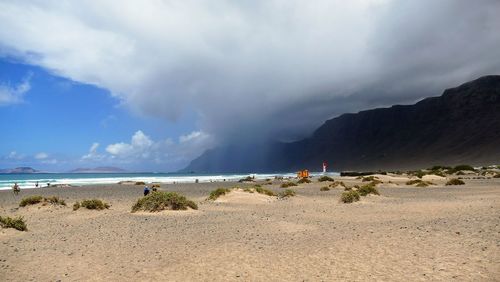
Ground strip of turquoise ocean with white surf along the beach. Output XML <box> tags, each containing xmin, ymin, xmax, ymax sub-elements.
<box><xmin>0</xmin><ymin>172</ymin><xmax>339</xmax><ymax>190</ymax></box>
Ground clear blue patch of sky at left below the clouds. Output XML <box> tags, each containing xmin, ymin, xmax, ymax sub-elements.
<box><xmin>0</xmin><ymin>58</ymin><xmax>207</xmax><ymax>171</ymax></box>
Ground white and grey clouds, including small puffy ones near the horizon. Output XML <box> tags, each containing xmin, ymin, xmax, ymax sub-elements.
<box><xmin>0</xmin><ymin>0</ymin><xmax>500</xmax><ymax>164</ymax></box>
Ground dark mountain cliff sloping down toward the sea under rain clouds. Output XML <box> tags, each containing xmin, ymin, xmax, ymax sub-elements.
<box><xmin>185</xmin><ymin>76</ymin><xmax>500</xmax><ymax>172</ymax></box>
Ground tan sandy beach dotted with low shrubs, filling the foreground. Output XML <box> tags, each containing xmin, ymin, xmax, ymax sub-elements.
<box><xmin>0</xmin><ymin>176</ymin><xmax>500</xmax><ymax>281</ymax></box>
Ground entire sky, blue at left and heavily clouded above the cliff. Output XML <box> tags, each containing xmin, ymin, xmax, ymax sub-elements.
<box><xmin>0</xmin><ymin>0</ymin><xmax>500</xmax><ymax>171</ymax></box>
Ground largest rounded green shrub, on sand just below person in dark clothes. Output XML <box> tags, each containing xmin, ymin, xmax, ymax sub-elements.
<box><xmin>132</xmin><ymin>192</ymin><xmax>198</xmax><ymax>212</ymax></box>
